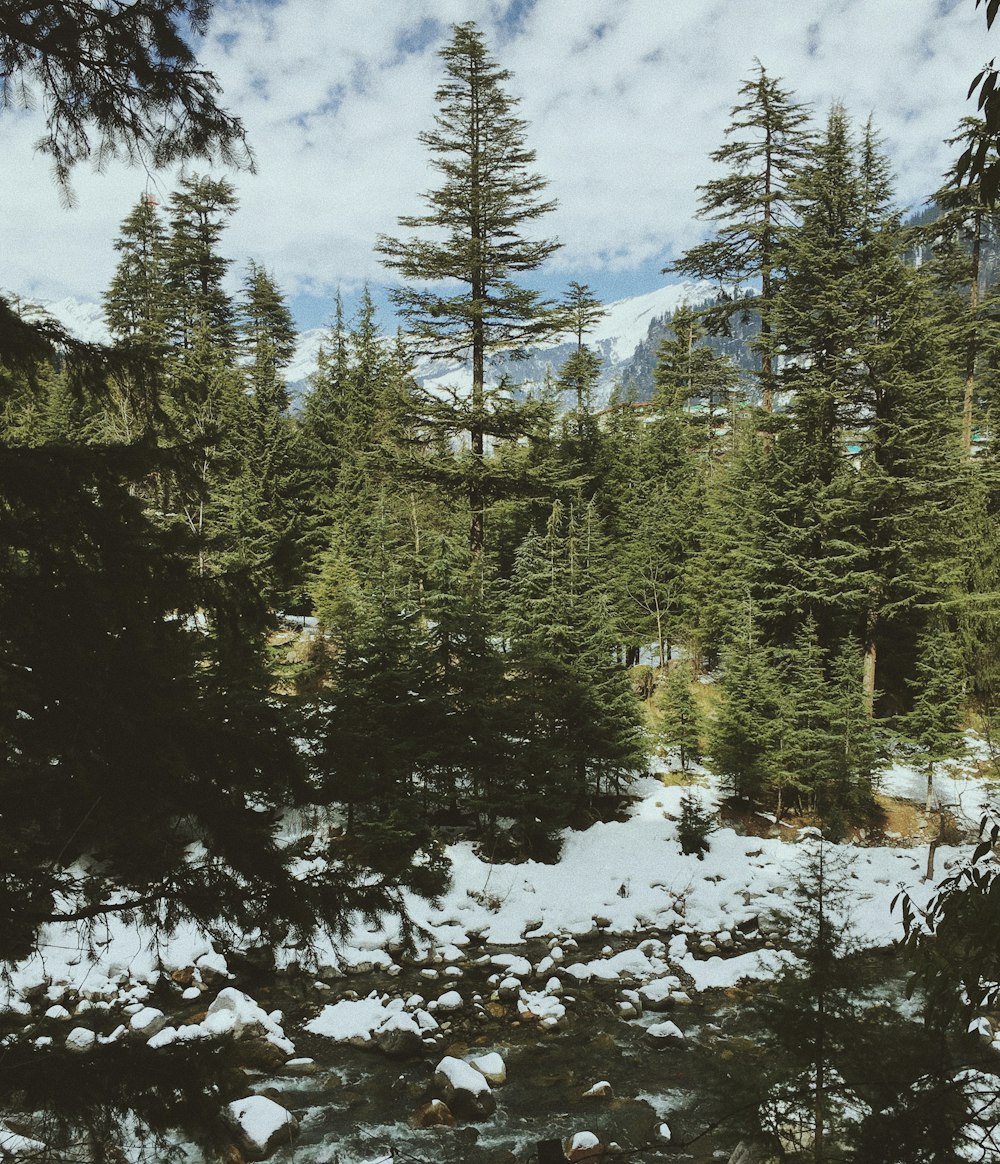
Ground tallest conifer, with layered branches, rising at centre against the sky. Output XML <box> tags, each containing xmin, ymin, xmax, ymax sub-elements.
<box><xmin>377</xmin><ymin>22</ymin><xmax>560</xmax><ymax>553</ymax></box>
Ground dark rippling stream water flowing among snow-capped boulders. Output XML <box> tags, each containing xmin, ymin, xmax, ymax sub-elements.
<box><xmin>230</xmin><ymin>950</ymin><xmax>917</xmax><ymax>1164</ymax></box>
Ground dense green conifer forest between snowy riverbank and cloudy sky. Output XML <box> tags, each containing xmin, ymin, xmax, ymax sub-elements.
<box><xmin>0</xmin><ymin>6</ymin><xmax>1000</xmax><ymax>1159</ymax></box>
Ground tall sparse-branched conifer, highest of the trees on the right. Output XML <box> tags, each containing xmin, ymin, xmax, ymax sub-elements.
<box><xmin>668</xmin><ymin>62</ymin><xmax>809</xmax><ymax>412</ymax></box>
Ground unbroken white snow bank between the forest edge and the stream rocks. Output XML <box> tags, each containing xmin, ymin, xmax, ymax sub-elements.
<box><xmin>0</xmin><ymin>744</ymin><xmax>986</xmax><ymax>1013</ymax></box>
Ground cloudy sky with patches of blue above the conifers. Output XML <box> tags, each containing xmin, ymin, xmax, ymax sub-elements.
<box><xmin>0</xmin><ymin>0</ymin><xmax>1000</xmax><ymax>328</ymax></box>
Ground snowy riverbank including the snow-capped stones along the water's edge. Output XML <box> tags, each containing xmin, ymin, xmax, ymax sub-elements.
<box><xmin>0</xmin><ymin>750</ymin><xmax>1000</xmax><ymax>1155</ymax></box>
